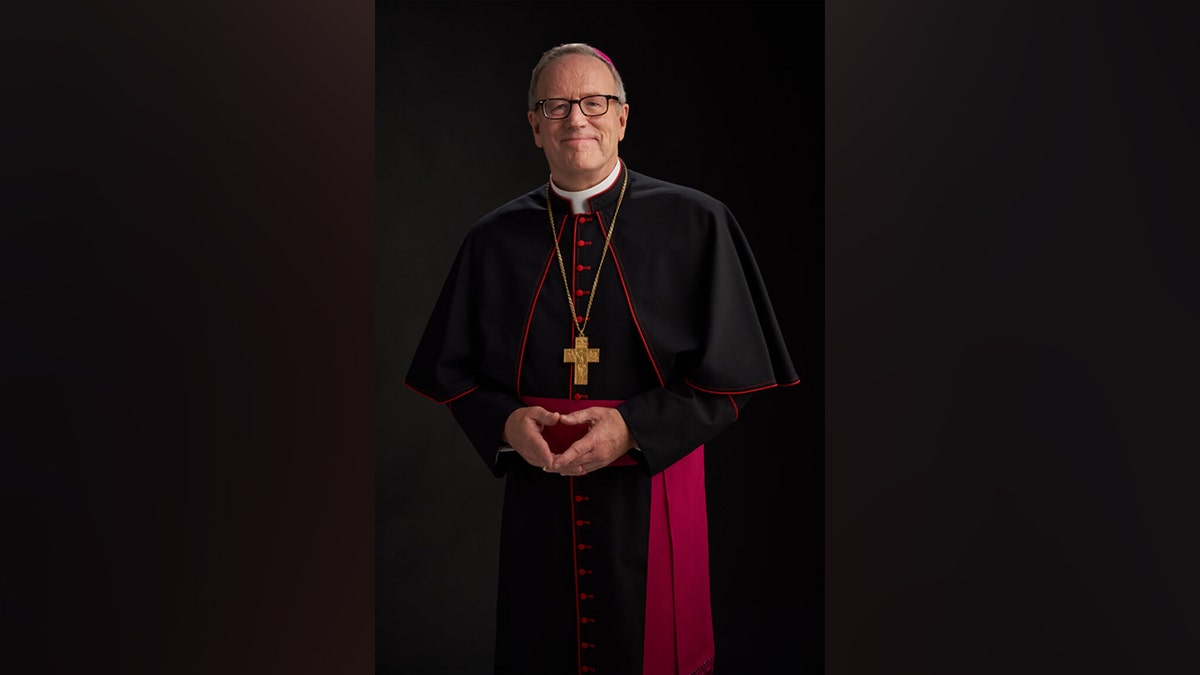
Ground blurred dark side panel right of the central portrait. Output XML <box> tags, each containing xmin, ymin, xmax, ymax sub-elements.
<box><xmin>826</xmin><ymin>2</ymin><xmax>1200</xmax><ymax>675</ymax></box>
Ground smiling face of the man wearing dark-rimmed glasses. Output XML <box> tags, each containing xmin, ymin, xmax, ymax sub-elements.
<box><xmin>529</xmin><ymin>54</ymin><xmax>629</xmax><ymax>190</ymax></box>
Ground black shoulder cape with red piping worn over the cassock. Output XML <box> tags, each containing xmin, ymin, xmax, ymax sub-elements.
<box><xmin>404</xmin><ymin>168</ymin><xmax>799</xmax><ymax>404</ymax></box>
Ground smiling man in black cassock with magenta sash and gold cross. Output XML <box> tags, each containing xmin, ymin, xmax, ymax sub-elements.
<box><xmin>406</xmin><ymin>43</ymin><xmax>798</xmax><ymax>675</ymax></box>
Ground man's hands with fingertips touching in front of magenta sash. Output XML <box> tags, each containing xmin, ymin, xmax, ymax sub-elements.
<box><xmin>504</xmin><ymin>406</ymin><xmax>635</xmax><ymax>476</ymax></box>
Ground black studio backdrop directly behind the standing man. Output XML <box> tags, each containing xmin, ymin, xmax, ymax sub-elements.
<box><xmin>376</xmin><ymin>2</ymin><xmax>824</xmax><ymax>674</ymax></box>
